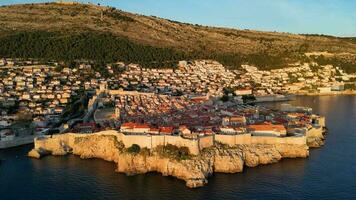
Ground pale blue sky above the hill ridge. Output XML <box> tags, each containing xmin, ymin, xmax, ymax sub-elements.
<box><xmin>0</xmin><ymin>0</ymin><xmax>356</xmax><ymax>37</ymax></box>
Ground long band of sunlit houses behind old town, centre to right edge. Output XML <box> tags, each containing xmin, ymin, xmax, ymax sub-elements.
<box><xmin>102</xmin><ymin>60</ymin><xmax>352</xmax><ymax>100</ymax></box>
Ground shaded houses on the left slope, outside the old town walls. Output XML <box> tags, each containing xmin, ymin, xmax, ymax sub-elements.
<box><xmin>0</xmin><ymin>59</ymin><xmax>109</xmax><ymax>138</ymax></box>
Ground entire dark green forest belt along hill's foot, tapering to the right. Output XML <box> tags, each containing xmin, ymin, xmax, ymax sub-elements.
<box><xmin>0</xmin><ymin>31</ymin><xmax>312</xmax><ymax>70</ymax></box>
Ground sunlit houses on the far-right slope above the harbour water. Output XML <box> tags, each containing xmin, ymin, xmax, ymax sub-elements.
<box><xmin>239</xmin><ymin>63</ymin><xmax>351</xmax><ymax>96</ymax></box>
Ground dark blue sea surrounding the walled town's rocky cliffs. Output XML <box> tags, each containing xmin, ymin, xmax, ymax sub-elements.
<box><xmin>0</xmin><ymin>96</ymin><xmax>356</xmax><ymax>200</ymax></box>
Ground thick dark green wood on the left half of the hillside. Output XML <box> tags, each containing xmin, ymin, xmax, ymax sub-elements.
<box><xmin>0</xmin><ymin>31</ymin><xmax>187</xmax><ymax>68</ymax></box>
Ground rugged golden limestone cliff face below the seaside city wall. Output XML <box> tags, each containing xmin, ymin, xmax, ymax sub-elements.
<box><xmin>28</xmin><ymin>134</ymin><xmax>309</xmax><ymax>188</ymax></box>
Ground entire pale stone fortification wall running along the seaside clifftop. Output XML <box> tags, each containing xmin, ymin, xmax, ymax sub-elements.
<box><xmin>35</xmin><ymin>130</ymin><xmax>306</xmax><ymax>155</ymax></box>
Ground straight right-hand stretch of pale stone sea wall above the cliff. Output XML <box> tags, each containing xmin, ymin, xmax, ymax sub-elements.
<box><xmin>215</xmin><ymin>134</ymin><xmax>307</xmax><ymax>146</ymax></box>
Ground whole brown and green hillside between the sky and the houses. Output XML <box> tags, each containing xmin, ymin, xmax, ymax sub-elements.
<box><xmin>0</xmin><ymin>3</ymin><xmax>356</xmax><ymax>72</ymax></box>
